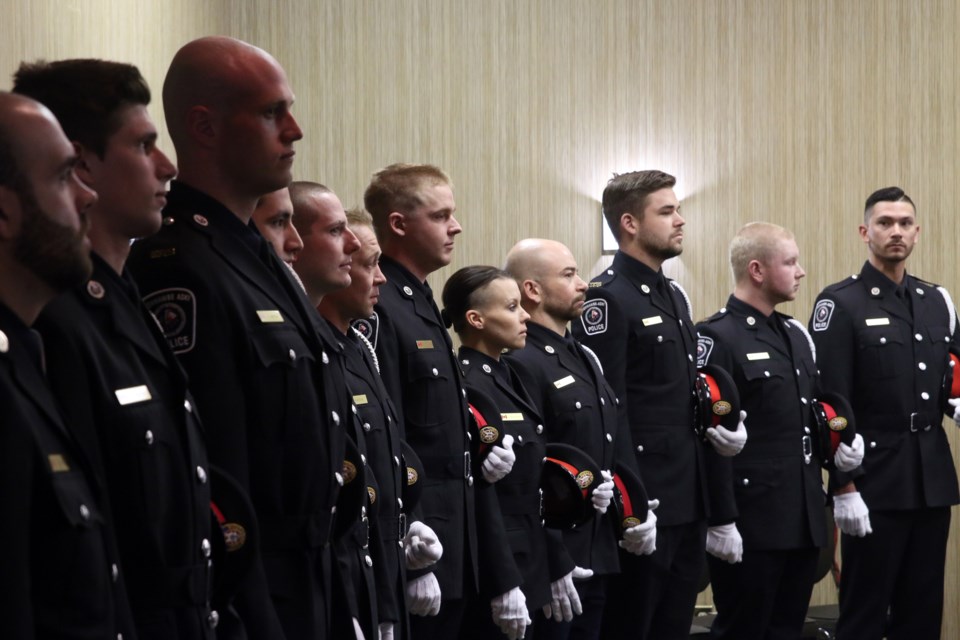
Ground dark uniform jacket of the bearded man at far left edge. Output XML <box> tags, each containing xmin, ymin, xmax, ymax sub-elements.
<box><xmin>0</xmin><ymin>305</ymin><xmax>135</xmax><ymax>640</ymax></box>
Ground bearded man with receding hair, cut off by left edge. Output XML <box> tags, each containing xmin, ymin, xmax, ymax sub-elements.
<box><xmin>0</xmin><ymin>93</ymin><xmax>134</xmax><ymax>639</ymax></box>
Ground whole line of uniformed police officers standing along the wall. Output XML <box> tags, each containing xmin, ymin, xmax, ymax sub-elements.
<box><xmin>0</xmin><ymin>37</ymin><xmax>960</xmax><ymax>640</ymax></box>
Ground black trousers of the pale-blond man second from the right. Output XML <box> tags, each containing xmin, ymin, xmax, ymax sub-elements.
<box><xmin>707</xmin><ymin>547</ymin><xmax>819</xmax><ymax>640</ymax></box>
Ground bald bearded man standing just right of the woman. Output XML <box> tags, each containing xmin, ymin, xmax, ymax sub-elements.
<box><xmin>506</xmin><ymin>238</ymin><xmax>657</xmax><ymax>640</ymax></box>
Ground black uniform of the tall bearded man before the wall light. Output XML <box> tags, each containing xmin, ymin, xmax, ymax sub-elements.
<box><xmin>573</xmin><ymin>252</ymin><xmax>712</xmax><ymax>640</ymax></box>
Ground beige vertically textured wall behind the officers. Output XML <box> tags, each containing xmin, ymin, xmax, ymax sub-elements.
<box><xmin>0</xmin><ymin>0</ymin><xmax>960</xmax><ymax>638</ymax></box>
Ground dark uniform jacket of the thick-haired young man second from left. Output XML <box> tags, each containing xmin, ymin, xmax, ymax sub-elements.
<box><xmin>35</xmin><ymin>254</ymin><xmax>219</xmax><ymax>640</ymax></box>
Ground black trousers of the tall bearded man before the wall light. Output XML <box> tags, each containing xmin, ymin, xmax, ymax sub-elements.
<box><xmin>600</xmin><ymin>520</ymin><xmax>707</xmax><ymax>640</ymax></box>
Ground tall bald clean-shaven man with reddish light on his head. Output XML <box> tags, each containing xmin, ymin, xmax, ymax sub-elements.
<box><xmin>128</xmin><ymin>37</ymin><xmax>352</xmax><ymax>640</ymax></box>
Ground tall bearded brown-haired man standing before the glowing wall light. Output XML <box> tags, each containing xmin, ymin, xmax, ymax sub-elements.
<box><xmin>573</xmin><ymin>171</ymin><xmax>746</xmax><ymax>640</ymax></box>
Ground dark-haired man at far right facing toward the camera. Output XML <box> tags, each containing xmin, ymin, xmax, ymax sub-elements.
<box><xmin>810</xmin><ymin>187</ymin><xmax>960</xmax><ymax>640</ymax></box>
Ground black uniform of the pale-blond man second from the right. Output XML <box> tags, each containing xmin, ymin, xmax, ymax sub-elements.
<box><xmin>697</xmin><ymin>295</ymin><xmax>832</xmax><ymax>640</ymax></box>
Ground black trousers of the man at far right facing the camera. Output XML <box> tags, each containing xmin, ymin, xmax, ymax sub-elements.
<box><xmin>837</xmin><ymin>507</ymin><xmax>950</xmax><ymax>640</ymax></box>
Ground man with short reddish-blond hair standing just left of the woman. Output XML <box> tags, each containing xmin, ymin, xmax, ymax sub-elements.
<box><xmin>364</xmin><ymin>164</ymin><xmax>497</xmax><ymax>638</ymax></box>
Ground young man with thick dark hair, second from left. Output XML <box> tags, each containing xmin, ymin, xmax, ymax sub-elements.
<box><xmin>14</xmin><ymin>60</ymin><xmax>217</xmax><ymax>638</ymax></box>
